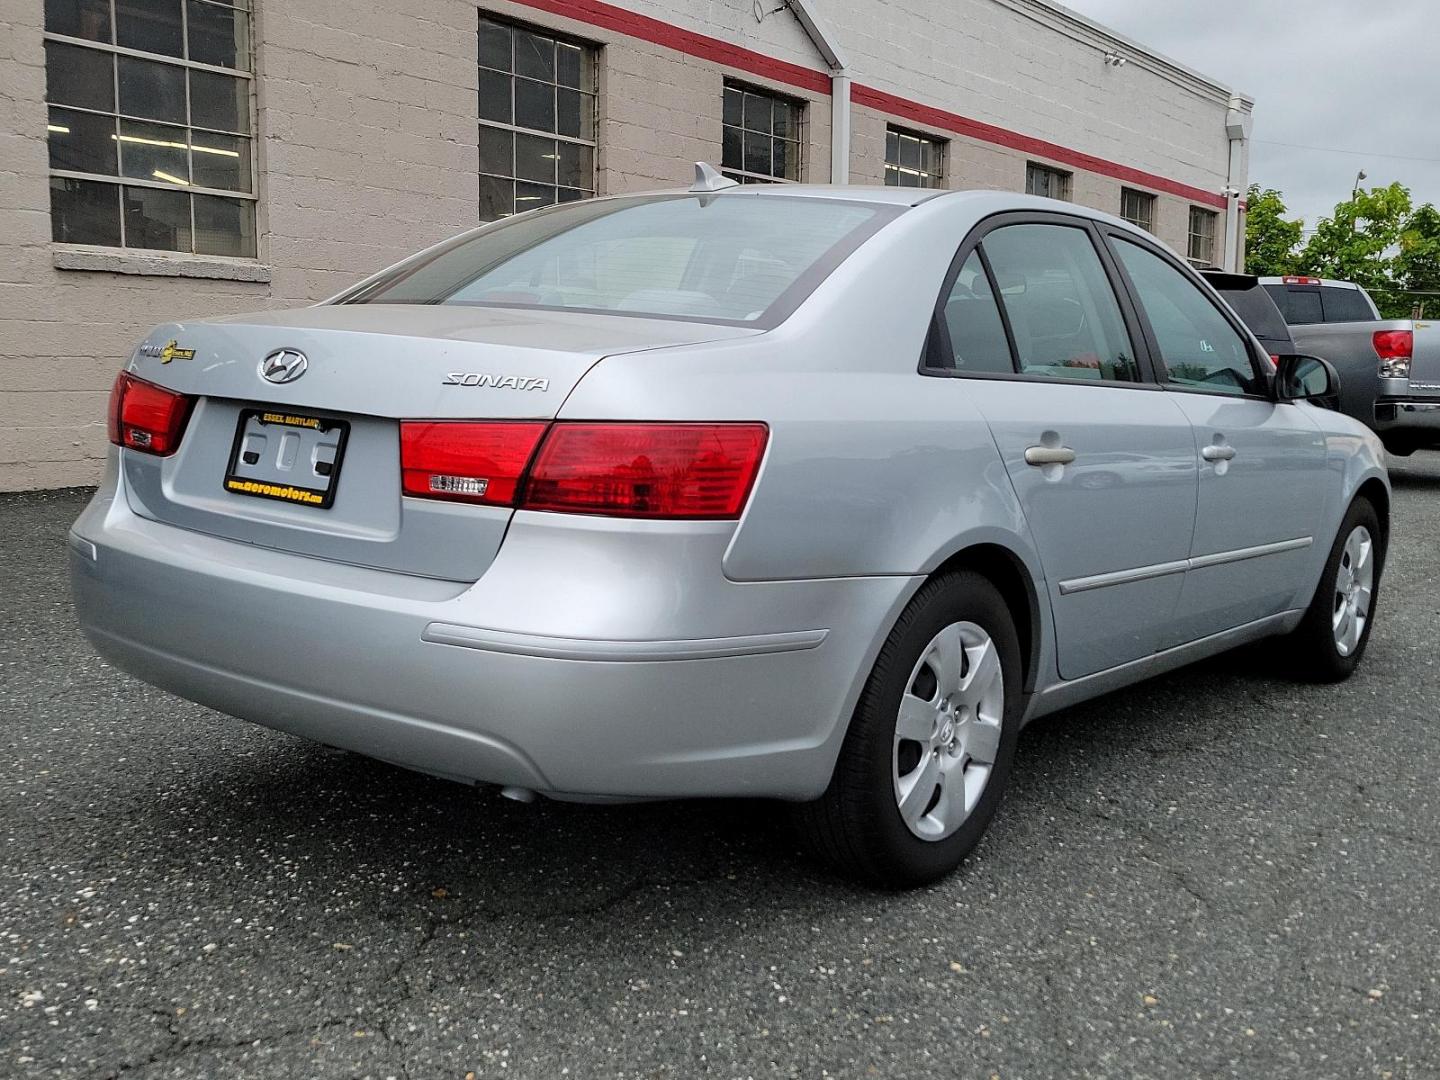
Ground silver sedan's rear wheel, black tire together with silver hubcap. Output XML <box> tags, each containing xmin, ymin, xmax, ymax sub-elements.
<box><xmin>798</xmin><ymin>572</ymin><xmax>1021</xmax><ymax>888</ymax></box>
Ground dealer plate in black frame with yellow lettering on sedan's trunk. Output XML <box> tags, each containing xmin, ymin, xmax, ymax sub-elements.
<box><xmin>225</xmin><ymin>409</ymin><xmax>350</xmax><ymax>510</ymax></box>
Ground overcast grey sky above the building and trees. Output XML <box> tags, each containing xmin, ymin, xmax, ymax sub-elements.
<box><xmin>1063</xmin><ymin>0</ymin><xmax>1440</xmax><ymax>229</ymax></box>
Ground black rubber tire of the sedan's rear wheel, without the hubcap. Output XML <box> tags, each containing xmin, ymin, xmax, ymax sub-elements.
<box><xmin>795</xmin><ymin>570</ymin><xmax>1024</xmax><ymax>888</ymax></box>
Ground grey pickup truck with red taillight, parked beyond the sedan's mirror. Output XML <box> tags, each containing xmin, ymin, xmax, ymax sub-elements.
<box><xmin>1260</xmin><ymin>276</ymin><xmax>1440</xmax><ymax>455</ymax></box>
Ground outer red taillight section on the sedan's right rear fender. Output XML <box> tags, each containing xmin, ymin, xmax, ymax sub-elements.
<box><xmin>521</xmin><ymin>423</ymin><xmax>769</xmax><ymax>518</ymax></box>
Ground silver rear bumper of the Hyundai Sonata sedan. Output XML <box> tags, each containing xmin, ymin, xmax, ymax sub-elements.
<box><xmin>71</xmin><ymin>472</ymin><xmax>914</xmax><ymax>799</ymax></box>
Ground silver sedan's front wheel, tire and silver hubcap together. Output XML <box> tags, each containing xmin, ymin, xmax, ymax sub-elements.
<box><xmin>1292</xmin><ymin>498</ymin><xmax>1385</xmax><ymax>683</ymax></box>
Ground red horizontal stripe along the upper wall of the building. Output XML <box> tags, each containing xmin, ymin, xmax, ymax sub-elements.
<box><xmin>506</xmin><ymin>0</ymin><xmax>1225</xmax><ymax>210</ymax></box>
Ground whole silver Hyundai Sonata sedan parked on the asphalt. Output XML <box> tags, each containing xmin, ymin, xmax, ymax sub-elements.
<box><xmin>71</xmin><ymin>167</ymin><xmax>1390</xmax><ymax>886</ymax></box>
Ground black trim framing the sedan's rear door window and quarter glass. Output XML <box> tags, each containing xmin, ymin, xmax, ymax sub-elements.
<box><xmin>917</xmin><ymin>210</ymin><xmax>1166</xmax><ymax>390</ymax></box>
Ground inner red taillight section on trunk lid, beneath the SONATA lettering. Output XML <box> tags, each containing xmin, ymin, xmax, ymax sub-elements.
<box><xmin>400</xmin><ymin>420</ymin><xmax>546</xmax><ymax>507</ymax></box>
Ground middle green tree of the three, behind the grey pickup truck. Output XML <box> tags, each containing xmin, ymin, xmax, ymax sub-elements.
<box><xmin>1299</xmin><ymin>183</ymin><xmax>1413</xmax><ymax>318</ymax></box>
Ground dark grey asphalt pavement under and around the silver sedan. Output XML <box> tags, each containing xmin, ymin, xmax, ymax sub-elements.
<box><xmin>0</xmin><ymin>466</ymin><xmax>1440</xmax><ymax>1080</ymax></box>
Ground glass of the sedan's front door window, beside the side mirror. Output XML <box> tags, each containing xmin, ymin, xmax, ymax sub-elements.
<box><xmin>1115</xmin><ymin>239</ymin><xmax>1261</xmax><ymax>395</ymax></box>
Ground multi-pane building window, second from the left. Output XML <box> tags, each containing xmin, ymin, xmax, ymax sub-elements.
<box><xmin>480</xmin><ymin>16</ymin><xmax>595</xmax><ymax>222</ymax></box>
